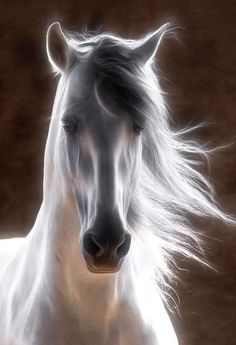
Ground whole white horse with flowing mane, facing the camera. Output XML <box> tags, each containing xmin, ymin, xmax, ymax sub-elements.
<box><xmin>0</xmin><ymin>23</ymin><xmax>230</xmax><ymax>345</ymax></box>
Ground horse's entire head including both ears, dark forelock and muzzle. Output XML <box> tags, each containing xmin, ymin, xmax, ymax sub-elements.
<box><xmin>47</xmin><ymin>23</ymin><xmax>168</xmax><ymax>272</ymax></box>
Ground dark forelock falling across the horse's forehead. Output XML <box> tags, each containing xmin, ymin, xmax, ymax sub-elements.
<box><xmin>87</xmin><ymin>37</ymin><xmax>150</xmax><ymax>125</ymax></box>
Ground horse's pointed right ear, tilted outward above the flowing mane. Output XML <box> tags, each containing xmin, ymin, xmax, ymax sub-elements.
<box><xmin>133</xmin><ymin>23</ymin><xmax>170</xmax><ymax>64</ymax></box>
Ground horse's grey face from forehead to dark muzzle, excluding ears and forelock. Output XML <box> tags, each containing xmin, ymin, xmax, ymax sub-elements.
<box><xmin>61</xmin><ymin>66</ymin><xmax>141</xmax><ymax>273</ymax></box>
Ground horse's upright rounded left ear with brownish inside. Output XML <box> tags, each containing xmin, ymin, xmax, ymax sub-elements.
<box><xmin>46</xmin><ymin>22</ymin><xmax>70</xmax><ymax>72</ymax></box>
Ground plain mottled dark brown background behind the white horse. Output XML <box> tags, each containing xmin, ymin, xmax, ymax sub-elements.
<box><xmin>0</xmin><ymin>0</ymin><xmax>236</xmax><ymax>345</ymax></box>
